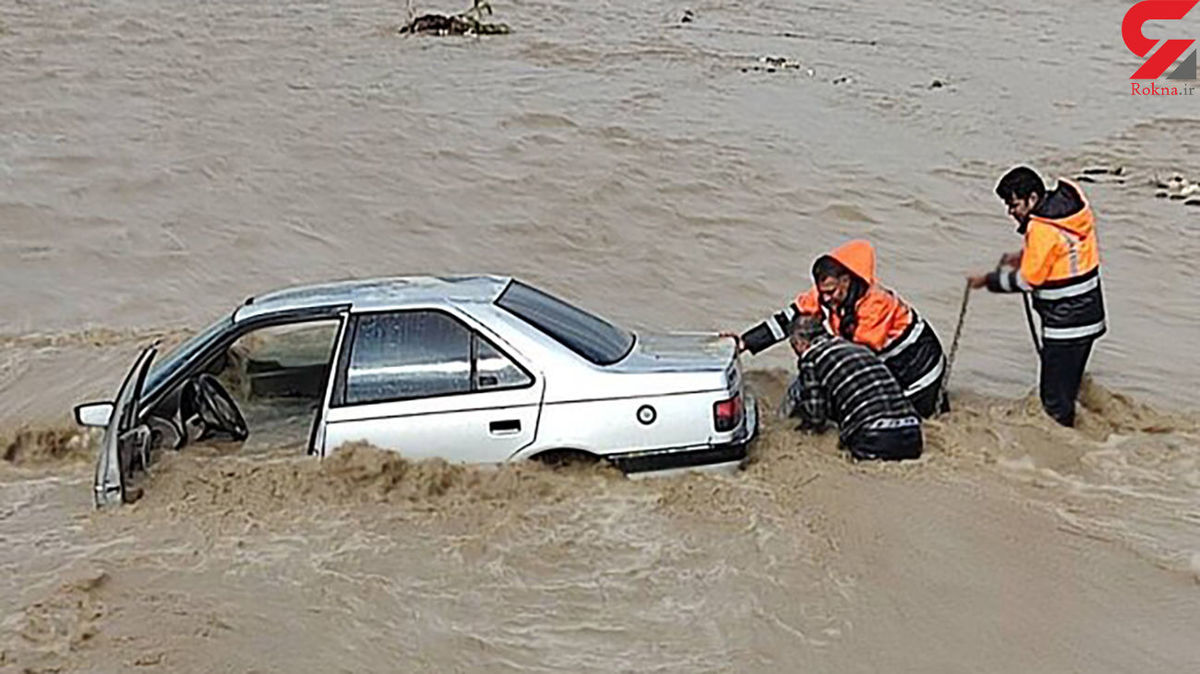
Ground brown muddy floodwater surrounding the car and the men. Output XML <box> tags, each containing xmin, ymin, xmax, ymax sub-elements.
<box><xmin>0</xmin><ymin>0</ymin><xmax>1200</xmax><ymax>673</ymax></box>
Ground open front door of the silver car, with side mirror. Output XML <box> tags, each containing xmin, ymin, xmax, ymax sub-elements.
<box><xmin>90</xmin><ymin>342</ymin><xmax>158</xmax><ymax>507</ymax></box>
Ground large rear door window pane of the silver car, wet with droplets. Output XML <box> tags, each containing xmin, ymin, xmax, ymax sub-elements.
<box><xmin>346</xmin><ymin>311</ymin><xmax>473</xmax><ymax>404</ymax></box>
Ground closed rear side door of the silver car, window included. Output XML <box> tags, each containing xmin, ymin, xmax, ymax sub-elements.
<box><xmin>320</xmin><ymin>309</ymin><xmax>544</xmax><ymax>463</ymax></box>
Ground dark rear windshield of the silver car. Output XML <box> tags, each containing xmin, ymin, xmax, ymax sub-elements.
<box><xmin>496</xmin><ymin>281</ymin><xmax>634</xmax><ymax>365</ymax></box>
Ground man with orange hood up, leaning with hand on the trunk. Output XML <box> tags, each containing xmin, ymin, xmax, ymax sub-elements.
<box><xmin>733</xmin><ymin>240</ymin><xmax>948</xmax><ymax>419</ymax></box>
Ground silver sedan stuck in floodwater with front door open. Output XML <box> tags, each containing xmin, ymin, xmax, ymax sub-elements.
<box><xmin>74</xmin><ymin>276</ymin><xmax>757</xmax><ymax>506</ymax></box>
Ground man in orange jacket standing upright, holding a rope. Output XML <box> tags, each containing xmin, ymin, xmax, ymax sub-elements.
<box><xmin>967</xmin><ymin>167</ymin><xmax>1108</xmax><ymax>426</ymax></box>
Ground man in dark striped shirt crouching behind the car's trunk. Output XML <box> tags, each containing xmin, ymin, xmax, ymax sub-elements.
<box><xmin>784</xmin><ymin>314</ymin><xmax>924</xmax><ymax>461</ymax></box>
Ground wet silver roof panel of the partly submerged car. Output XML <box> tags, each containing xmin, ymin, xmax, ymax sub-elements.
<box><xmin>234</xmin><ymin>276</ymin><xmax>512</xmax><ymax>321</ymax></box>
